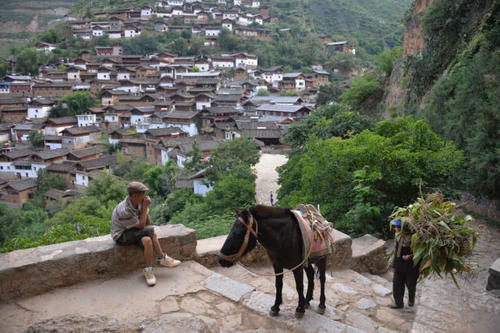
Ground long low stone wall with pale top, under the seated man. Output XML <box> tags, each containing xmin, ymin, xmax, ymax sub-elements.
<box><xmin>0</xmin><ymin>225</ymin><xmax>196</xmax><ymax>301</ymax></box>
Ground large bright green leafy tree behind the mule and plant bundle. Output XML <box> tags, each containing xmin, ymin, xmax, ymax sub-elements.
<box><xmin>278</xmin><ymin>117</ymin><xmax>463</xmax><ymax>237</ymax></box>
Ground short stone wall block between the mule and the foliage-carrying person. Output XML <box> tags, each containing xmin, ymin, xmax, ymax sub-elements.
<box><xmin>351</xmin><ymin>235</ymin><xmax>389</xmax><ymax>274</ymax></box>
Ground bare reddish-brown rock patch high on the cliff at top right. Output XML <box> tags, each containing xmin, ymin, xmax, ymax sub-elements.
<box><xmin>403</xmin><ymin>0</ymin><xmax>433</xmax><ymax>55</ymax></box>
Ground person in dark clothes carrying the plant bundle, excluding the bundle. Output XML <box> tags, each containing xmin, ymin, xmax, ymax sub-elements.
<box><xmin>390</xmin><ymin>220</ymin><xmax>419</xmax><ymax>309</ymax></box>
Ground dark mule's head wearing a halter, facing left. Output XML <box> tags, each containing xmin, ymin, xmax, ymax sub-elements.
<box><xmin>217</xmin><ymin>209</ymin><xmax>257</xmax><ymax>267</ymax></box>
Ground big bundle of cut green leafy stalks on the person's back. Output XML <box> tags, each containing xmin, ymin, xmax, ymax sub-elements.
<box><xmin>391</xmin><ymin>193</ymin><xmax>478</xmax><ymax>288</ymax></box>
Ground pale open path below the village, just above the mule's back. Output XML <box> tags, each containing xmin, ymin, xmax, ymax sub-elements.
<box><xmin>255</xmin><ymin>153</ymin><xmax>288</xmax><ymax>205</ymax></box>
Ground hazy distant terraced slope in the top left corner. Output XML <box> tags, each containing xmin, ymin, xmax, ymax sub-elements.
<box><xmin>0</xmin><ymin>0</ymin><xmax>79</xmax><ymax>57</ymax></box>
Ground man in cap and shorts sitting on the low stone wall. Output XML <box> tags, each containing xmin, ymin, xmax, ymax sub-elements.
<box><xmin>111</xmin><ymin>182</ymin><xmax>181</xmax><ymax>286</ymax></box>
